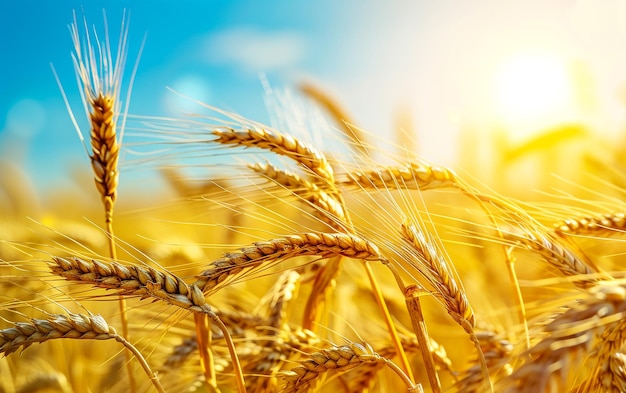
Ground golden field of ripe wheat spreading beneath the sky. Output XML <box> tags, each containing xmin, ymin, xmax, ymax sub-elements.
<box><xmin>0</xmin><ymin>12</ymin><xmax>626</xmax><ymax>392</ymax></box>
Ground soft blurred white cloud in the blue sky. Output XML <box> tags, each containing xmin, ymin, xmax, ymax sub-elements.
<box><xmin>205</xmin><ymin>27</ymin><xmax>305</xmax><ymax>72</ymax></box>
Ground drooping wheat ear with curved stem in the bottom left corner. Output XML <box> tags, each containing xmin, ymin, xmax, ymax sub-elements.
<box><xmin>0</xmin><ymin>314</ymin><xmax>165</xmax><ymax>392</ymax></box>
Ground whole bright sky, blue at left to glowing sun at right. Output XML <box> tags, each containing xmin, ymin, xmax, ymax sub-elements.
<box><xmin>0</xmin><ymin>0</ymin><xmax>626</xmax><ymax>201</ymax></box>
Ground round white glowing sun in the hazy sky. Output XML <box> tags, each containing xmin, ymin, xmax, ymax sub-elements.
<box><xmin>494</xmin><ymin>53</ymin><xmax>573</xmax><ymax>138</ymax></box>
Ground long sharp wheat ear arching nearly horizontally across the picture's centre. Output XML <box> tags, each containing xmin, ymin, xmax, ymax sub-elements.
<box><xmin>195</xmin><ymin>232</ymin><xmax>385</xmax><ymax>292</ymax></box>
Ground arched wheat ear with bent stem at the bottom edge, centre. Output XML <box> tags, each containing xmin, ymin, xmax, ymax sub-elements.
<box><xmin>282</xmin><ymin>343</ymin><xmax>422</xmax><ymax>393</ymax></box>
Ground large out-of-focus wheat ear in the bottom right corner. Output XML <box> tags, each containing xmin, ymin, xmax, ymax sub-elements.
<box><xmin>501</xmin><ymin>283</ymin><xmax>626</xmax><ymax>392</ymax></box>
